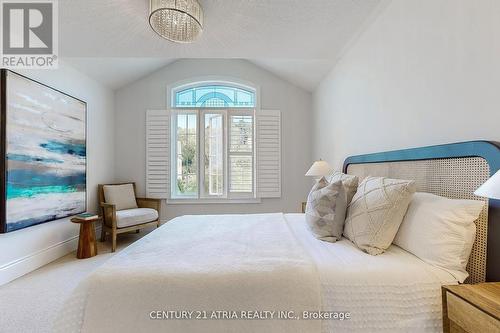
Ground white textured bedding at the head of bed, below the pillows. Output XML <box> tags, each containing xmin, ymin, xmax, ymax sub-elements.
<box><xmin>285</xmin><ymin>214</ymin><xmax>457</xmax><ymax>333</ymax></box>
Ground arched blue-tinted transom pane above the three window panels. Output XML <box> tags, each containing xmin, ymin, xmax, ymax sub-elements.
<box><xmin>173</xmin><ymin>83</ymin><xmax>255</xmax><ymax>108</ymax></box>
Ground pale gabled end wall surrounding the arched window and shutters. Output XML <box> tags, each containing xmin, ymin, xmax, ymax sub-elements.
<box><xmin>115</xmin><ymin>59</ymin><xmax>312</xmax><ymax>219</ymax></box>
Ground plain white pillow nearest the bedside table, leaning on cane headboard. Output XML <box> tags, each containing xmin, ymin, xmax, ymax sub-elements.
<box><xmin>394</xmin><ymin>193</ymin><xmax>484</xmax><ymax>282</ymax></box>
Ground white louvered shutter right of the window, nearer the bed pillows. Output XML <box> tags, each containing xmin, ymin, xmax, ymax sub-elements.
<box><xmin>255</xmin><ymin>110</ymin><xmax>281</xmax><ymax>198</ymax></box>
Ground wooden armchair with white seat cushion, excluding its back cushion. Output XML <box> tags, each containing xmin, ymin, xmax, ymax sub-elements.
<box><xmin>97</xmin><ymin>182</ymin><xmax>161</xmax><ymax>252</ymax></box>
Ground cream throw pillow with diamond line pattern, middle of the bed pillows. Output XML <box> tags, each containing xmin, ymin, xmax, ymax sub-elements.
<box><xmin>344</xmin><ymin>177</ymin><xmax>416</xmax><ymax>255</ymax></box>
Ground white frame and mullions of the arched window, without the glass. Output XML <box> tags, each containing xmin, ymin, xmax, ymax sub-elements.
<box><xmin>167</xmin><ymin>77</ymin><xmax>261</xmax><ymax>204</ymax></box>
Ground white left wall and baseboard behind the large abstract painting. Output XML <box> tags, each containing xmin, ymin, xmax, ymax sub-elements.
<box><xmin>0</xmin><ymin>61</ymin><xmax>114</xmax><ymax>285</ymax></box>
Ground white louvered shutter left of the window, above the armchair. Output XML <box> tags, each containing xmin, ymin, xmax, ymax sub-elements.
<box><xmin>146</xmin><ymin>110</ymin><xmax>170</xmax><ymax>199</ymax></box>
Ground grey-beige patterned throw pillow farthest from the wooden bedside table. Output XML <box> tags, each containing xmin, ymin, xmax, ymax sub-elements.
<box><xmin>306</xmin><ymin>177</ymin><xmax>347</xmax><ymax>242</ymax></box>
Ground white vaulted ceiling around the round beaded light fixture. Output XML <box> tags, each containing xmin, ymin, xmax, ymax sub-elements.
<box><xmin>59</xmin><ymin>0</ymin><xmax>384</xmax><ymax>91</ymax></box>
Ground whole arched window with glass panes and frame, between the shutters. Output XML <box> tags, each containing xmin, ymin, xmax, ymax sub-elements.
<box><xmin>171</xmin><ymin>81</ymin><xmax>256</xmax><ymax>199</ymax></box>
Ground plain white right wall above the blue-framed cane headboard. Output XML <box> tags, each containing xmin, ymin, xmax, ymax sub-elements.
<box><xmin>313</xmin><ymin>0</ymin><xmax>500</xmax><ymax>168</ymax></box>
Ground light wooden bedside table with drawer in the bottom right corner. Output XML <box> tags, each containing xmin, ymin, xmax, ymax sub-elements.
<box><xmin>442</xmin><ymin>282</ymin><xmax>500</xmax><ymax>333</ymax></box>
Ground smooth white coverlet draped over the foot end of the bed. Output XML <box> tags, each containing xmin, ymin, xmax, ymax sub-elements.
<box><xmin>56</xmin><ymin>213</ymin><xmax>321</xmax><ymax>333</ymax></box>
